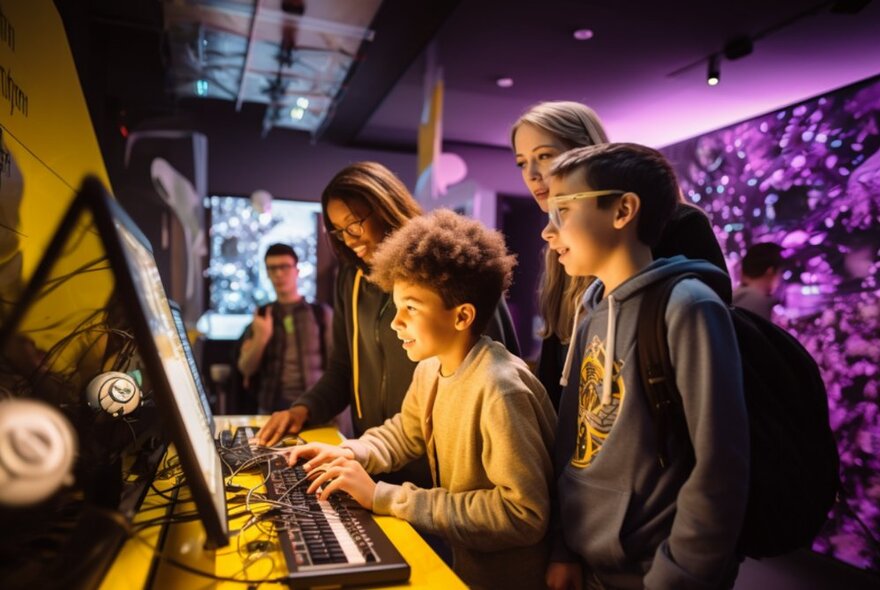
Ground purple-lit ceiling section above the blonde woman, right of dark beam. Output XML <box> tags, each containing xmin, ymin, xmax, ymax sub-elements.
<box><xmin>359</xmin><ymin>0</ymin><xmax>880</xmax><ymax>146</ymax></box>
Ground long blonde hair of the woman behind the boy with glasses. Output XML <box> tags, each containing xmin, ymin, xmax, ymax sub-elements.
<box><xmin>510</xmin><ymin>100</ymin><xmax>608</xmax><ymax>343</ymax></box>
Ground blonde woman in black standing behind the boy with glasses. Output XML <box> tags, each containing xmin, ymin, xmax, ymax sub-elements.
<box><xmin>510</xmin><ymin>101</ymin><xmax>727</xmax><ymax>407</ymax></box>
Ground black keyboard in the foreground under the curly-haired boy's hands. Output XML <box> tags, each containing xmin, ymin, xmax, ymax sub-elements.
<box><xmin>264</xmin><ymin>454</ymin><xmax>410</xmax><ymax>586</ymax></box>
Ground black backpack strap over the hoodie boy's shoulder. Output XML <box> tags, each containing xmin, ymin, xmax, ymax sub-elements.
<box><xmin>636</xmin><ymin>273</ymin><xmax>698</xmax><ymax>467</ymax></box>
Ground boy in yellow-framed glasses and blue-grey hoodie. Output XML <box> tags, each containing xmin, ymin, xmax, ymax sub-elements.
<box><xmin>547</xmin><ymin>144</ymin><xmax>749</xmax><ymax>590</ymax></box>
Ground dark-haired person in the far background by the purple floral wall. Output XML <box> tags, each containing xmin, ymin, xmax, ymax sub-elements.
<box><xmin>733</xmin><ymin>242</ymin><xmax>783</xmax><ymax>320</ymax></box>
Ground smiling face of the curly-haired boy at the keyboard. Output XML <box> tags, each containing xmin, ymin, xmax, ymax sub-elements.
<box><xmin>391</xmin><ymin>281</ymin><xmax>460</xmax><ymax>362</ymax></box>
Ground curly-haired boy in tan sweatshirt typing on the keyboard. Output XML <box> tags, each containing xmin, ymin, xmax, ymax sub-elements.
<box><xmin>288</xmin><ymin>210</ymin><xmax>556</xmax><ymax>588</ymax></box>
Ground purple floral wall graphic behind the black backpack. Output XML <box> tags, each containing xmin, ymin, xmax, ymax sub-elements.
<box><xmin>662</xmin><ymin>77</ymin><xmax>880</xmax><ymax>571</ymax></box>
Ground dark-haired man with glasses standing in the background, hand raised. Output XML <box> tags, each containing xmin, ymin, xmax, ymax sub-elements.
<box><xmin>237</xmin><ymin>244</ymin><xmax>333</xmax><ymax>414</ymax></box>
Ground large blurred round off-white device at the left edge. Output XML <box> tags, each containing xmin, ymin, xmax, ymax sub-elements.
<box><xmin>0</xmin><ymin>399</ymin><xmax>77</xmax><ymax>507</ymax></box>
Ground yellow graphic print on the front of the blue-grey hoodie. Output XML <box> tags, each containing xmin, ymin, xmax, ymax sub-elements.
<box><xmin>571</xmin><ymin>336</ymin><xmax>626</xmax><ymax>468</ymax></box>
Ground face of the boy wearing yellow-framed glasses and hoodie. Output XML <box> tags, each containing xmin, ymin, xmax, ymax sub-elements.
<box><xmin>547</xmin><ymin>172</ymin><xmax>620</xmax><ymax>278</ymax></box>
